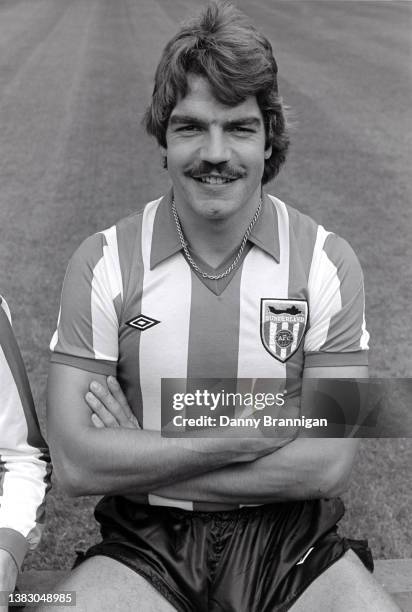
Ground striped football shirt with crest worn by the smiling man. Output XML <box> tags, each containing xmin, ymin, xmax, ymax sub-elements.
<box><xmin>51</xmin><ymin>193</ymin><xmax>369</xmax><ymax>508</ymax></box>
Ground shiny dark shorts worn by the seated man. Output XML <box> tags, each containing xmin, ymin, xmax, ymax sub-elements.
<box><xmin>76</xmin><ymin>496</ymin><xmax>373</xmax><ymax>612</ymax></box>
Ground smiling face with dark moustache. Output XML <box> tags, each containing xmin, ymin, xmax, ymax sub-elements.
<box><xmin>162</xmin><ymin>75</ymin><xmax>272</xmax><ymax>219</ymax></box>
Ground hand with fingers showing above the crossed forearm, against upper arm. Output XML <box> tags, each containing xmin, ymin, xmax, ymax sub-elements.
<box><xmin>85</xmin><ymin>376</ymin><xmax>141</xmax><ymax>429</ymax></box>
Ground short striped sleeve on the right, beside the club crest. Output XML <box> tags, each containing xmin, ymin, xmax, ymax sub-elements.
<box><xmin>304</xmin><ymin>228</ymin><xmax>369</xmax><ymax>367</ymax></box>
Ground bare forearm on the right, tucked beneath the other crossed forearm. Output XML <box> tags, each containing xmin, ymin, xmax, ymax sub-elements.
<box><xmin>153</xmin><ymin>438</ymin><xmax>357</xmax><ymax>504</ymax></box>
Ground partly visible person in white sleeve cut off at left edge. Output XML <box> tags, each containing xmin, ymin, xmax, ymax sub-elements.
<box><xmin>0</xmin><ymin>297</ymin><xmax>50</xmax><ymax>610</ymax></box>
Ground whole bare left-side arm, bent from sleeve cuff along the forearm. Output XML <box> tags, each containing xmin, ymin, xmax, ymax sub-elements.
<box><xmin>48</xmin><ymin>364</ymin><xmax>292</xmax><ymax>495</ymax></box>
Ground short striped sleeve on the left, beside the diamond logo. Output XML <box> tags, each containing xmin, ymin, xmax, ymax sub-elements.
<box><xmin>50</xmin><ymin>227</ymin><xmax>122</xmax><ymax>375</ymax></box>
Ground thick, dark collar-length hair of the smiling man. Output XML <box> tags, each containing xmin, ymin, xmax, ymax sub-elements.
<box><xmin>143</xmin><ymin>1</ymin><xmax>289</xmax><ymax>184</ymax></box>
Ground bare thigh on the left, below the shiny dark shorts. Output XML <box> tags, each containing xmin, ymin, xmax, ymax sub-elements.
<box><xmin>37</xmin><ymin>555</ymin><xmax>176</xmax><ymax>612</ymax></box>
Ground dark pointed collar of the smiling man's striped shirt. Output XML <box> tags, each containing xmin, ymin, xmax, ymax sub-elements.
<box><xmin>150</xmin><ymin>189</ymin><xmax>280</xmax><ymax>270</ymax></box>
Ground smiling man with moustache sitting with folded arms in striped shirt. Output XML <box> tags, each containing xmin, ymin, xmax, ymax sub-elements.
<box><xmin>44</xmin><ymin>4</ymin><xmax>396</xmax><ymax>612</ymax></box>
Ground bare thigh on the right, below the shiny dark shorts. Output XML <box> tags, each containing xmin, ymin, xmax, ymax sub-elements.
<box><xmin>291</xmin><ymin>550</ymin><xmax>400</xmax><ymax>612</ymax></box>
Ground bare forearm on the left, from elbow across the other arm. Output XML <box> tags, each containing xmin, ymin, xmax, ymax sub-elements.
<box><xmin>51</xmin><ymin>426</ymin><xmax>284</xmax><ymax>495</ymax></box>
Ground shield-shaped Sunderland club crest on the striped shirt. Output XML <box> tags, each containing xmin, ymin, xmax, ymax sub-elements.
<box><xmin>260</xmin><ymin>298</ymin><xmax>308</xmax><ymax>363</ymax></box>
